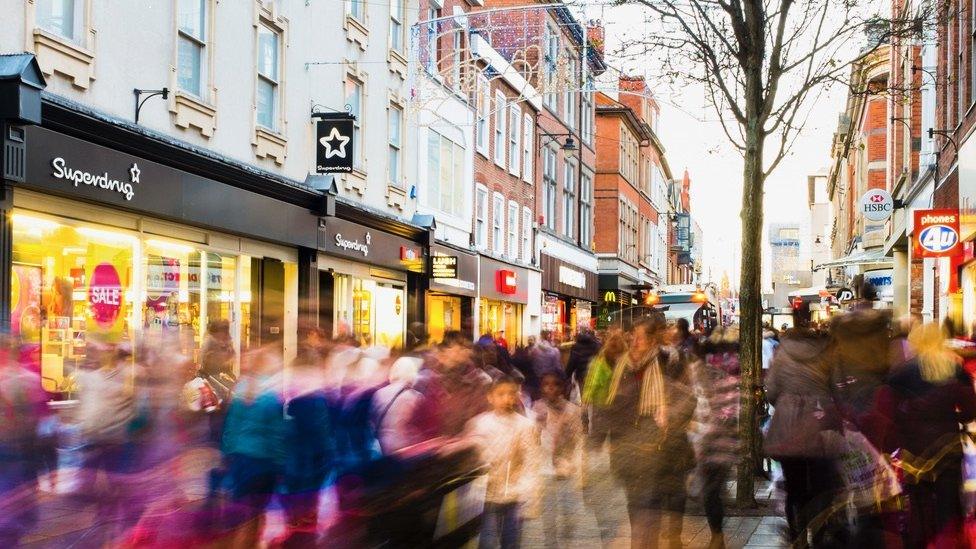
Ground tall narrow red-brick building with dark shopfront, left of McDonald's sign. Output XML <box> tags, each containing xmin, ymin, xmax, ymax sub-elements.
<box><xmin>471</xmin><ymin>0</ymin><xmax>606</xmax><ymax>337</ymax></box>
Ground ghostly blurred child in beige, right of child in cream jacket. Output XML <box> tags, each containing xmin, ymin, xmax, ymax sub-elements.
<box><xmin>532</xmin><ymin>372</ymin><xmax>583</xmax><ymax>547</ymax></box>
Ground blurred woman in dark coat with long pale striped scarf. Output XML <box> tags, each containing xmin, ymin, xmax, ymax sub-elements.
<box><xmin>594</xmin><ymin>316</ymin><xmax>694</xmax><ymax>548</ymax></box>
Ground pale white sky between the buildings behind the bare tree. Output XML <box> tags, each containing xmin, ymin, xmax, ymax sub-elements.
<box><xmin>586</xmin><ymin>5</ymin><xmax>846</xmax><ymax>284</ymax></box>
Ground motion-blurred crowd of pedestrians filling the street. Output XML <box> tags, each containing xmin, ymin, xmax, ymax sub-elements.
<box><xmin>0</xmin><ymin>309</ymin><xmax>976</xmax><ymax>548</ymax></box>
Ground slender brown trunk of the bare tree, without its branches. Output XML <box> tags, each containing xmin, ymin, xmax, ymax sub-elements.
<box><xmin>735</xmin><ymin>119</ymin><xmax>765</xmax><ymax>507</ymax></box>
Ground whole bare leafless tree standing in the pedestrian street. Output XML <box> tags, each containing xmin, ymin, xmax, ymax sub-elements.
<box><xmin>615</xmin><ymin>0</ymin><xmax>924</xmax><ymax>506</ymax></box>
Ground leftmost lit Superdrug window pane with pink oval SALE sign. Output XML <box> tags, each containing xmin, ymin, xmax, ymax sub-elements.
<box><xmin>11</xmin><ymin>214</ymin><xmax>139</xmax><ymax>397</ymax></box>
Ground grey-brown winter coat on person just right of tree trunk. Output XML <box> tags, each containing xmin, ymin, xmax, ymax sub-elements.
<box><xmin>764</xmin><ymin>335</ymin><xmax>841</xmax><ymax>458</ymax></box>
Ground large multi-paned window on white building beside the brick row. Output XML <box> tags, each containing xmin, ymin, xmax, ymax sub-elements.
<box><xmin>427</xmin><ymin>130</ymin><xmax>464</xmax><ymax>215</ymax></box>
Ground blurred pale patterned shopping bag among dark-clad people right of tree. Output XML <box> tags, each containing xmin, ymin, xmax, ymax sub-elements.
<box><xmin>837</xmin><ymin>428</ymin><xmax>902</xmax><ymax>509</ymax></box>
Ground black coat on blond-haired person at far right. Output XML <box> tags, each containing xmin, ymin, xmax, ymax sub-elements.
<box><xmin>878</xmin><ymin>359</ymin><xmax>976</xmax><ymax>479</ymax></box>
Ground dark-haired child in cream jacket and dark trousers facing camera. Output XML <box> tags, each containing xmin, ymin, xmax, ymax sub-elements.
<box><xmin>468</xmin><ymin>377</ymin><xmax>539</xmax><ymax>549</ymax></box>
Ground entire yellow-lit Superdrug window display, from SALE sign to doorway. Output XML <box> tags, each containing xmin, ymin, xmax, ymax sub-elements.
<box><xmin>11</xmin><ymin>212</ymin><xmax>262</xmax><ymax>399</ymax></box>
